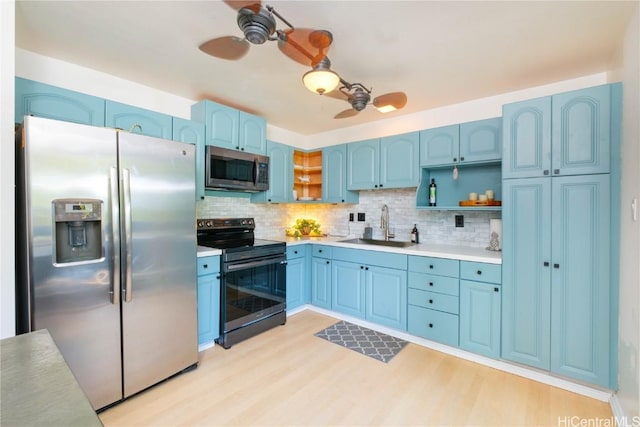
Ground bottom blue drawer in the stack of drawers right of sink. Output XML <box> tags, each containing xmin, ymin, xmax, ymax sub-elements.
<box><xmin>407</xmin><ymin>305</ymin><xmax>458</xmax><ymax>347</ymax></box>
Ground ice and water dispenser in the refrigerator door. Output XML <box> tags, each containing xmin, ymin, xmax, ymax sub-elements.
<box><xmin>52</xmin><ymin>199</ymin><xmax>103</xmax><ymax>264</ymax></box>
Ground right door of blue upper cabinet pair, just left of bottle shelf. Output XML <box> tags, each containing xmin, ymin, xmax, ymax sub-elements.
<box><xmin>380</xmin><ymin>132</ymin><xmax>420</xmax><ymax>188</ymax></box>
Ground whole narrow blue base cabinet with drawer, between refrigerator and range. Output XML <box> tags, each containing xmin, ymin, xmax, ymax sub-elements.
<box><xmin>198</xmin><ymin>256</ymin><xmax>220</xmax><ymax>345</ymax></box>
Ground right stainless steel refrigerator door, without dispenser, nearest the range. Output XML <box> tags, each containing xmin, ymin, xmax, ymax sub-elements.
<box><xmin>118</xmin><ymin>132</ymin><xmax>198</xmax><ymax>397</ymax></box>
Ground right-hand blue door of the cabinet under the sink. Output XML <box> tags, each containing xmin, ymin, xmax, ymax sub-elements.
<box><xmin>365</xmin><ymin>267</ymin><xmax>407</xmax><ymax>331</ymax></box>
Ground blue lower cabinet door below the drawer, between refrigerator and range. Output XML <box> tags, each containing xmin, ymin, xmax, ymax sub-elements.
<box><xmin>198</xmin><ymin>273</ymin><xmax>220</xmax><ymax>345</ymax></box>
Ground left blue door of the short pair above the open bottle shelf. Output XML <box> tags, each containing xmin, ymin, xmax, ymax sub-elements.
<box><xmin>420</xmin><ymin>125</ymin><xmax>460</xmax><ymax>166</ymax></box>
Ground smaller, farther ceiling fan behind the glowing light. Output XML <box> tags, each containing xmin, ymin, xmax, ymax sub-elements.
<box><xmin>326</xmin><ymin>78</ymin><xmax>407</xmax><ymax>119</ymax></box>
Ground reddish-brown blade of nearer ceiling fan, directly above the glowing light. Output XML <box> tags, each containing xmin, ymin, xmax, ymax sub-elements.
<box><xmin>278</xmin><ymin>28</ymin><xmax>333</xmax><ymax>67</ymax></box>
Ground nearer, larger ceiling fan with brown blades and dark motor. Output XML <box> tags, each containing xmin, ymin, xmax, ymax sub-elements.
<box><xmin>199</xmin><ymin>0</ymin><xmax>333</xmax><ymax>67</ymax></box>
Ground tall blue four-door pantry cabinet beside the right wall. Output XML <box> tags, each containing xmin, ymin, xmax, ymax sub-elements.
<box><xmin>502</xmin><ymin>84</ymin><xmax>621</xmax><ymax>388</ymax></box>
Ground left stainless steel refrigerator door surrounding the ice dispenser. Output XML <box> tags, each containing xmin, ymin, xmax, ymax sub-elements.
<box><xmin>16</xmin><ymin>117</ymin><xmax>122</xmax><ymax>409</ymax></box>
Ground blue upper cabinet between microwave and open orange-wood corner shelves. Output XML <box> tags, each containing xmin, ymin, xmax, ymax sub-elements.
<box><xmin>251</xmin><ymin>141</ymin><xmax>293</xmax><ymax>203</ymax></box>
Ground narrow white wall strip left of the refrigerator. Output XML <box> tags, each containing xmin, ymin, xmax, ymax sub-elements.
<box><xmin>0</xmin><ymin>0</ymin><xmax>15</xmax><ymax>338</ymax></box>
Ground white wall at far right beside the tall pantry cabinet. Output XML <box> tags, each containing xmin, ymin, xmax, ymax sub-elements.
<box><xmin>617</xmin><ymin>1</ymin><xmax>640</xmax><ymax>425</ymax></box>
